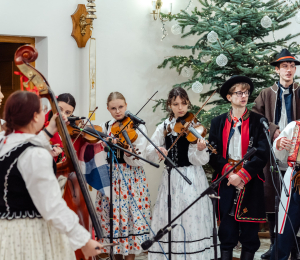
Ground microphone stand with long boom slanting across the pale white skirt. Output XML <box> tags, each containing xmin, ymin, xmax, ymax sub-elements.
<box><xmin>142</xmin><ymin>147</ymin><xmax>257</xmax><ymax>260</ymax></box>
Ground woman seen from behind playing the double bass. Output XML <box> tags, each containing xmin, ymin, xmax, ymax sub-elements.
<box><xmin>0</xmin><ymin>91</ymin><xmax>102</xmax><ymax>260</ymax></box>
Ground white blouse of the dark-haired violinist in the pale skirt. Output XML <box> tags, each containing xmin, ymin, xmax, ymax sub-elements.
<box><xmin>146</xmin><ymin>118</ymin><xmax>209</xmax><ymax>166</ymax></box>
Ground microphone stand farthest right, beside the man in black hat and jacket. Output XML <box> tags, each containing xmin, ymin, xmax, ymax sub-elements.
<box><xmin>263</xmin><ymin>126</ymin><xmax>289</xmax><ymax>260</ymax></box>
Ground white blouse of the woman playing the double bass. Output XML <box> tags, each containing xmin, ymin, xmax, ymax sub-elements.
<box><xmin>0</xmin><ymin>131</ymin><xmax>91</xmax><ymax>251</ymax></box>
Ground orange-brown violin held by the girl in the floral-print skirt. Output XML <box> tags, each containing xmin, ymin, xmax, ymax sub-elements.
<box><xmin>110</xmin><ymin>117</ymin><xmax>141</xmax><ymax>157</ymax></box>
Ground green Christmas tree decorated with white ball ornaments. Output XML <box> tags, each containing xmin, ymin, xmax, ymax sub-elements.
<box><xmin>154</xmin><ymin>0</ymin><xmax>300</xmax><ymax>128</ymax></box>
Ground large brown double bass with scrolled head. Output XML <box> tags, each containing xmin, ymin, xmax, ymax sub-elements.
<box><xmin>14</xmin><ymin>45</ymin><xmax>115</xmax><ymax>260</ymax></box>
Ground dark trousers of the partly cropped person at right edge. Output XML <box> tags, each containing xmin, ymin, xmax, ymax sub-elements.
<box><xmin>271</xmin><ymin>188</ymin><xmax>300</xmax><ymax>260</ymax></box>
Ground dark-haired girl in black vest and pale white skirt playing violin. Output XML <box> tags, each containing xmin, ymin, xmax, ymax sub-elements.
<box><xmin>147</xmin><ymin>87</ymin><xmax>218</xmax><ymax>260</ymax></box>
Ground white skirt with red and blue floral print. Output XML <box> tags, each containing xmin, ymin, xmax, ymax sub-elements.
<box><xmin>96</xmin><ymin>164</ymin><xmax>151</xmax><ymax>255</ymax></box>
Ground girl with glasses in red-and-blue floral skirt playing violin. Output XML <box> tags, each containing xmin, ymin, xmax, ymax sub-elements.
<box><xmin>96</xmin><ymin>92</ymin><xmax>151</xmax><ymax>260</ymax></box>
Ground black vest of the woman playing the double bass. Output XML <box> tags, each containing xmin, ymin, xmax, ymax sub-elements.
<box><xmin>0</xmin><ymin>142</ymin><xmax>56</xmax><ymax>220</ymax></box>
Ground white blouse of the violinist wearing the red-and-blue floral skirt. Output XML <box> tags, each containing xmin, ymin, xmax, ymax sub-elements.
<box><xmin>100</xmin><ymin>119</ymin><xmax>148</xmax><ymax>166</ymax></box>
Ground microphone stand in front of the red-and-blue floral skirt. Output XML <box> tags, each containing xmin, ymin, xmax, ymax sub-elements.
<box><xmin>70</xmin><ymin>122</ymin><xmax>159</xmax><ymax>260</ymax></box>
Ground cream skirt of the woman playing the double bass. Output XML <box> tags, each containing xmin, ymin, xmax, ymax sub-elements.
<box><xmin>0</xmin><ymin>218</ymin><xmax>76</xmax><ymax>260</ymax></box>
